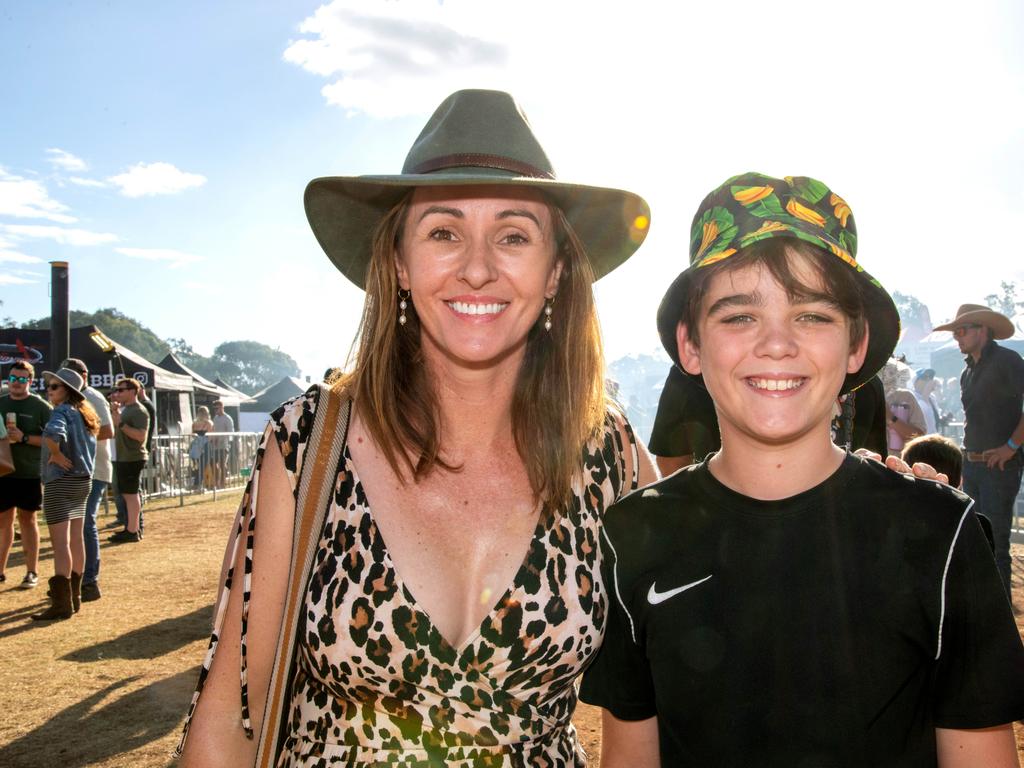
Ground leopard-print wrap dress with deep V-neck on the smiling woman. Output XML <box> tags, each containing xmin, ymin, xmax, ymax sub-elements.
<box><xmin>177</xmin><ymin>395</ymin><xmax>639</xmax><ymax>768</ymax></box>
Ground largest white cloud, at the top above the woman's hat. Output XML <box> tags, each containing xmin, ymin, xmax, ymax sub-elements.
<box><xmin>284</xmin><ymin>0</ymin><xmax>508</xmax><ymax>118</ymax></box>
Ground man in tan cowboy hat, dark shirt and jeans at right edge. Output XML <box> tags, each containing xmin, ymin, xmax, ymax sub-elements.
<box><xmin>935</xmin><ymin>304</ymin><xmax>1024</xmax><ymax>595</ymax></box>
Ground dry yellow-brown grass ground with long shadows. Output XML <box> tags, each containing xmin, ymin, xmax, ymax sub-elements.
<box><xmin>0</xmin><ymin>494</ymin><xmax>1024</xmax><ymax>768</ymax></box>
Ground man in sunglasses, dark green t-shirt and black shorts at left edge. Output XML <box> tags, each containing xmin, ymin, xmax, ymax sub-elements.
<box><xmin>0</xmin><ymin>360</ymin><xmax>51</xmax><ymax>590</ymax></box>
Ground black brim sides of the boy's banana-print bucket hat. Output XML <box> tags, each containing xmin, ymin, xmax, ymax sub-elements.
<box><xmin>657</xmin><ymin>253</ymin><xmax>900</xmax><ymax>394</ymax></box>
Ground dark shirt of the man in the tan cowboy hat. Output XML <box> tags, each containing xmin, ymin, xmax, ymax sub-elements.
<box><xmin>961</xmin><ymin>341</ymin><xmax>1024</xmax><ymax>452</ymax></box>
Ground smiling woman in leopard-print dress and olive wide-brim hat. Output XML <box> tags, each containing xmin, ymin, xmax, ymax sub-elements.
<box><xmin>176</xmin><ymin>91</ymin><xmax>655</xmax><ymax>766</ymax></box>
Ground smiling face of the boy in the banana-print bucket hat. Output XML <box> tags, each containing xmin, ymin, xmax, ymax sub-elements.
<box><xmin>677</xmin><ymin>251</ymin><xmax>866</xmax><ymax>446</ymax></box>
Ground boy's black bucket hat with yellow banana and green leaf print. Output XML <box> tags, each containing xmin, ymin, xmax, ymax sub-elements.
<box><xmin>657</xmin><ymin>173</ymin><xmax>899</xmax><ymax>392</ymax></box>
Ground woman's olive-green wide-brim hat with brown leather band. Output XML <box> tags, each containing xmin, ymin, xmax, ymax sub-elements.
<box><xmin>305</xmin><ymin>90</ymin><xmax>650</xmax><ymax>288</ymax></box>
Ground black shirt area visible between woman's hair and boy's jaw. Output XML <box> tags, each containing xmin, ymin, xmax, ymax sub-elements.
<box><xmin>647</xmin><ymin>366</ymin><xmax>722</xmax><ymax>462</ymax></box>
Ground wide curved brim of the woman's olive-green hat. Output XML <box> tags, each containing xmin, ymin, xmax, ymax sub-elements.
<box><xmin>303</xmin><ymin>169</ymin><xmax>650</xmax><ymax>289</ymax></box>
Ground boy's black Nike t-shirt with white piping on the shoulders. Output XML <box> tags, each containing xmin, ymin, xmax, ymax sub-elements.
<box><xmin>580</xmin><ymin>456</ymin><xmax>1024</xmax><ymax>768</ymax></box>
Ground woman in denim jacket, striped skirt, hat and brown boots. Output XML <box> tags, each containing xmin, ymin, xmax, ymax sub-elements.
<box><xmin>32</xmin><ymin>368</ymin><xmax>99</xmax><ymax>622</ymax></box>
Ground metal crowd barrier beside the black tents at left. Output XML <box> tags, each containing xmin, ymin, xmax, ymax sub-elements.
<box><xmin>141</xmin><ymin>432</ymin><xmax>260</xmax><ymax>505</ymax></box>
